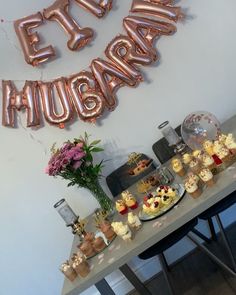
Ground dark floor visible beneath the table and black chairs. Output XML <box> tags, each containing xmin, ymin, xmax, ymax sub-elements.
<box><xmin>130</xmin><ymin>224</ymin><xmax>236</xmax><ymax>295</ymax></box>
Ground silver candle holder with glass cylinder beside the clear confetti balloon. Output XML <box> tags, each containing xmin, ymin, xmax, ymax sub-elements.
<box><xmin>158</xmin><ymin>121</ymin><xmax>186</xmax><ymax>154</ymax></box>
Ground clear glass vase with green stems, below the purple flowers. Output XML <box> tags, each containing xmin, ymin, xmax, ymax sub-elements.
<box><xmin>87</xmin><ymin>181</ymin><xmax>113</xmax><ymax>213</ymax></box>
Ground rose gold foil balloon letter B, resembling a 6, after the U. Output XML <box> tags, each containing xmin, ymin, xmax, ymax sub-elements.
<box><xmin>67</xmin><ymin>71</ymin><xmax>105</xmax><ymax>122</ymax></box>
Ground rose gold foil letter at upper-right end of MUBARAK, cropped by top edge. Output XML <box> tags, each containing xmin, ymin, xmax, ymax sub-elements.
<box><xmin>130</xmin><ymin>0</ymin><xmax>183</xmax><ymax>22</ymax></box>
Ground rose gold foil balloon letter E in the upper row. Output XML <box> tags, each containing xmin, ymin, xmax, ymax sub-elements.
<box><xmin>14</xmin><ymin>12</ymin><xmax>55</xmax><ymax>66</ymax></box>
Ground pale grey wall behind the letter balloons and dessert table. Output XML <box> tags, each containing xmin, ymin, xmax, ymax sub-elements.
<box><xmin>0</xmin><ymin>0</ymin><xmax>236</xmax><ymax>295</ymax></box>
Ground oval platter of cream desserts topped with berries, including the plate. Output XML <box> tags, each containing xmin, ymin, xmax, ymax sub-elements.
<box><xmin>139</xmin><ymin>184</ymin><xmax>185</xmax><ymax>221</ymax></box>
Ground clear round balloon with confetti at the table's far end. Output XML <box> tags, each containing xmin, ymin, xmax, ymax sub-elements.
<box><xmin>181</xmin><ymin>111</ymin><xmax>221</xmax><ymax>150</ymax></box>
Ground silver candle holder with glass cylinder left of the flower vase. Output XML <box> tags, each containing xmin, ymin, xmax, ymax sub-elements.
<box><xmin>54</xmin><ymin>199</ymin><xmax>86</xmax><ymax>237</ymax></box>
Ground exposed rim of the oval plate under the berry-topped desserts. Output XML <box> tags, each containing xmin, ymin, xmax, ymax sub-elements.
<box><xmin>139</xmin><ymin>183</ymin><xmax>185</xmax><ymax>221</ymax></box>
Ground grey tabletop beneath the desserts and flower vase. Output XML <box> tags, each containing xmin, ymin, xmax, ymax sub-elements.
<box><xmin>62</xmin><ymin>115</ymin><xmax>236</xmax><ymax>295</ymax></box>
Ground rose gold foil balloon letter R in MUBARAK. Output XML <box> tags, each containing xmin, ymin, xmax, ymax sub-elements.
<box><xmin>105</xmin><ymin>35</ymin><xmax>152</xmax><ymax>81</ymax></box>
